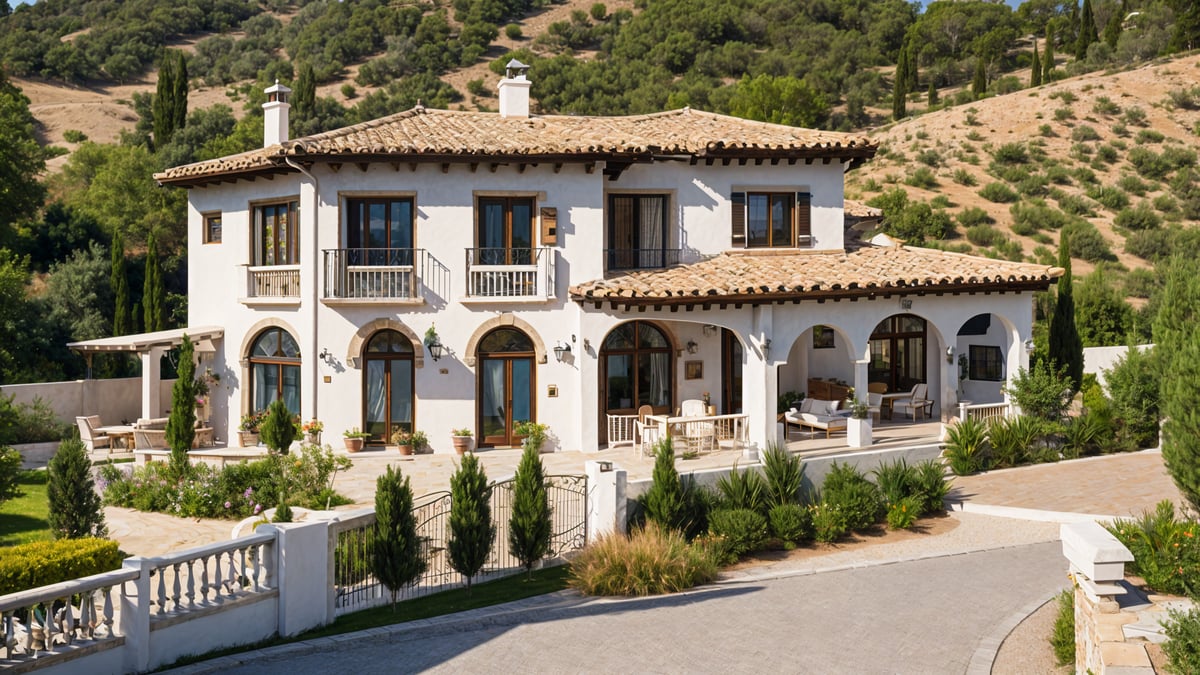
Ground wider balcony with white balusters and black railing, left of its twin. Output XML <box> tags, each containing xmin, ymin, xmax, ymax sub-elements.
<box><xmin>324</xmin><ymin>249</ymin><xmax>425</xmax><ymax>304</ymax></box>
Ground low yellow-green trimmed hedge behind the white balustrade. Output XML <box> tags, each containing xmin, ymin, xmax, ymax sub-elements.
<box><xmin>0</xmin><ymin>538</ymin><xmax>122</xmax><ymax>596</ymax></box>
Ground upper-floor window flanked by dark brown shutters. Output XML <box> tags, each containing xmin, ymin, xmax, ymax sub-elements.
<box><xmin>731</xmin><ymin>192</ymin><xmax>812</xmax><ymax>249</ymax></box>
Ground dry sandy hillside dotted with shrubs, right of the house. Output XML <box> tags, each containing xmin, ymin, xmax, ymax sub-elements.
<box><xmin>847</xmin><ymin>55</ymin><xmax>1200</xmax><ymax>274</ymax></box>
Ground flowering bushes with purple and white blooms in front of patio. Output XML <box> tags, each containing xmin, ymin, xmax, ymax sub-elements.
<box><xmin>98</xmin><ymin>446</ymin><xmax>350</xmax><ymax>519</ymax></box>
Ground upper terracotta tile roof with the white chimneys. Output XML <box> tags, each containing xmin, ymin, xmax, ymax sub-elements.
<box><xmin>155</xmin><ymin>107</ymin><xmax>877</xmax><ymax>183</ymax></box>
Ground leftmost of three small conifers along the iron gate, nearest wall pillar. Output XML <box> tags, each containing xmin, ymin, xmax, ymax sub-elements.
<box><xmin>371</xmin><ymin>466</ymin><xmax>428</xmax><ymax>611</ymax></box>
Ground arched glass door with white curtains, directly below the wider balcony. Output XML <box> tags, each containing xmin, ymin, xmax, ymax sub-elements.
<box><xmin>362</xmin><ymin>329</ymin><xmax>414</xmax><ymax>443</ymax></box>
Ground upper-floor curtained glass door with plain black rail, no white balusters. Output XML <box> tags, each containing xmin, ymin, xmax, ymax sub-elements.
<box><xmin>608</xmin><ymin>195</ymin><xmax>679</xmax><ymax>269</ymax></box>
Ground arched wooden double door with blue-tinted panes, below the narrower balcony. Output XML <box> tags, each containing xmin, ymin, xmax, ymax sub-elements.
<box><xmin>475</xmin><ymin>328</ymin><xmax>535</xmax><ymax>447</ymax></box>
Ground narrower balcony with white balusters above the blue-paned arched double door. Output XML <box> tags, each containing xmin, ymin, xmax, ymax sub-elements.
<box><xmin>467</xmin><ymin>247</ymin><xmax>554</xmax><ymax>301</ymax></box>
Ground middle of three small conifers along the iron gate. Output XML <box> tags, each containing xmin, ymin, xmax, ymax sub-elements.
<box><xmin>449</xmin><ymin>453</ymin><xmax>496</xmax><ymax>593</ymax></box>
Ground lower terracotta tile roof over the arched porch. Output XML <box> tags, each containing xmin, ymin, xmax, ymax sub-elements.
<box><xmin>570</xmin><ymin>244</ymin><xmax>1063</xmax><ymax>304</ymax></box>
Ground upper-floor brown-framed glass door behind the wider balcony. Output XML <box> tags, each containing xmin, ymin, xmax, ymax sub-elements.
<box><xmin>346</xmin><ymin>197</ymin><xmax>415</xmax><ymax>265</ymax></box>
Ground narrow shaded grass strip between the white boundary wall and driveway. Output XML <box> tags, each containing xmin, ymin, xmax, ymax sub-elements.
<box><xmin>163</xmin><ymin>565</ymin><xmax>570</xmax><ymax>669</ymax></box>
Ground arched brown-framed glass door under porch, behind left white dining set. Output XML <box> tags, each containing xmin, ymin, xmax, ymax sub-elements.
<box><xmin>600</xmin><ymin>321</ymin><xmax>674</xmax><ymax>429</ymax></box>
